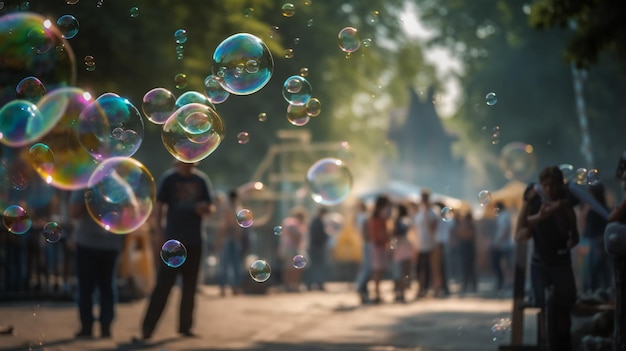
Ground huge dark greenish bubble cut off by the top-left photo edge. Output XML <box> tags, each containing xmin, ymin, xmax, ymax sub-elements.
<box><xmin>0</xmin><ymin>12</ymin><xmax>76</xmax><ymax>106</ymax></box>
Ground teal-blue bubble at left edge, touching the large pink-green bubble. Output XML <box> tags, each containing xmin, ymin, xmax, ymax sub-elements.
<box><xmin>0</xmin><ymin>100</ymin><xmax>45</xmax><ymax>147</ymax></box>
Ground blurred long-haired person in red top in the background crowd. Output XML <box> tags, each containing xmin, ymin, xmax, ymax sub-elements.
<box><xmin>367</xmin><ymin>195</ymin><xmax>391</xmax><ymax>303</ymax></box>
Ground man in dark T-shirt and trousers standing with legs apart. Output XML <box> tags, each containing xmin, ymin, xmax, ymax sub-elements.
<box><xmin>136</xmin><ymin>161</ymin><xmax>214</xmax><ymax>340</ymax></box>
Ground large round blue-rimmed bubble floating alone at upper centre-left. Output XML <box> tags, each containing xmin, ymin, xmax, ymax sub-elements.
<box><xmin>207</xmin><ymin>33</ymin><xmax>274</xmax><ymax>95</ymax></box>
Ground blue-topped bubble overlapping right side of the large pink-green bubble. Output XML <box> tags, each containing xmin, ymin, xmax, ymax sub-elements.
<box><xmin>76</xmin><ymin>93</ymin><xmax>144</xmax><ymax>161</ymax></box>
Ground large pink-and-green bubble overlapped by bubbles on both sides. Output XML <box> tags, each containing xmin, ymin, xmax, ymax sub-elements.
<box><xmin>32</xmin><ymin>88</ymin><xmax>98</xmax><ymax>190</ymax></box>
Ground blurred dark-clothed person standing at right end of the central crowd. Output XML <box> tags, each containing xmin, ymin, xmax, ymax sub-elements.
<box><xmin>455</xmin><ymin>210</ymin><xmax>478</xmax><ymax>293</ymax></box>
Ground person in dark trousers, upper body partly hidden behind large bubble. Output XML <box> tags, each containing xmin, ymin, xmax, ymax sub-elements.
<box><xmin>69</xmin><ymin>190</ymin><xmax>124</xmax><ymax>338</ymax></box>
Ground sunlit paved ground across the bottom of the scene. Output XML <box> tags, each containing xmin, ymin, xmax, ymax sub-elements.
<box><xmin>0</xmin><ymin>282</ymin><xmax>533</xmax><ymax>351</ymax></box>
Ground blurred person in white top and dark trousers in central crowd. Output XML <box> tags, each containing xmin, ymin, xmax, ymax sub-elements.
<box><xmin>414</xmin><ymin>190</ymin><xmax>438</xmax><ymax>299</ymax></box>
